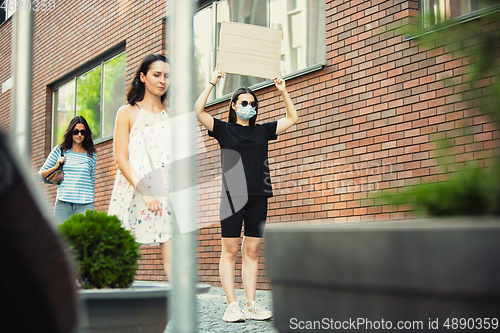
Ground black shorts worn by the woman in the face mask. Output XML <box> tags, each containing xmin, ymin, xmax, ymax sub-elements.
<box><xmin>220</xmin><ymin>197</ymin><xmax>267</xmax><ymax>238</ymax></box>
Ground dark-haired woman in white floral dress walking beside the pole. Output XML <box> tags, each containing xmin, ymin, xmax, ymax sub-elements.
<box><xmin>108</xmin><ymin>54</ymin><xmax>173</xmax><ymax>280</ymax></box>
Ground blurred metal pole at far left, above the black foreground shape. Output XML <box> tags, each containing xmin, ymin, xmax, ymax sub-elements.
<box><xmin>11</xmin><ymin>3</ymin><xmax>33</xmax><ymax>165</ymax></box>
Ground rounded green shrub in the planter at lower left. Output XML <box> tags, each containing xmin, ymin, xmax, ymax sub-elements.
<box><xmin>59</xmin><ymin>210</ymin><xmax>140</xmax><ymax>289</ymax></box>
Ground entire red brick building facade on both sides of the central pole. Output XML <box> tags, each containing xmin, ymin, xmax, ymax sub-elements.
<box><xmin>0</xmin><ymin>0</ymin><xmax>499</xmax><ymax>289</ymax></box>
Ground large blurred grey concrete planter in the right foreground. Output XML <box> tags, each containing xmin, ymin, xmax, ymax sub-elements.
<box><xmin>266</xmin><ymin>218</ymin><xmax>500</xmax><ymax>332</ymax></box>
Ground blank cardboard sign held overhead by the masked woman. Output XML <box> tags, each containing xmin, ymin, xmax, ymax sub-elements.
<box><xmin>218</xmin><ymin>22</ymin><xmax>282</xmax><ymax>79</ymax></box>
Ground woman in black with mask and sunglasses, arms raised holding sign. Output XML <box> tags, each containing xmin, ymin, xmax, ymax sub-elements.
<box><xmin>195</xmin><ymin>64</ymin><xmax>299</xmax><ymax>322</ymax></box>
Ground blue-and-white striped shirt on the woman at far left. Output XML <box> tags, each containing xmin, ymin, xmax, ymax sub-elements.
<box><xmin>38</xmin><ymin>146</ymin><xmax>97</xmax><ymax>204</ymax></box>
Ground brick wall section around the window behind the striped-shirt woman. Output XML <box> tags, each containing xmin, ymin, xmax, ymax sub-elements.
<box><xmin>27</xmin><ymin>0</ymin><xmax>164</xmax><ymax>204</ymax></box>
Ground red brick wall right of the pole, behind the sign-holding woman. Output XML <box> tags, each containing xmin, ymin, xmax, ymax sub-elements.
<box><xmin>199</xmin><ymin>0</ymin><xmax>499</xmax><ymax>289</ymax></box>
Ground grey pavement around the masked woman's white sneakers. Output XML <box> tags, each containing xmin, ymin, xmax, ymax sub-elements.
<box><xmin>165</xmin><ymin>287</ymin><xmax>278</xmax><ymax>333</ymax></box>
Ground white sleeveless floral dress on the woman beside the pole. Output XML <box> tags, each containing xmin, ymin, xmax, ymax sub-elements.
<box><xmin>108</xmin><ymin>106</ymin><xmax>173</xmax><ymax>244</ymax></box>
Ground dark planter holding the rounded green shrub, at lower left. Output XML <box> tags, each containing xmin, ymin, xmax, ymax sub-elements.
<box><xmin>78</xmin><ymin>281</ymin><xmax>210</xmax><ymax>333</ymax></box>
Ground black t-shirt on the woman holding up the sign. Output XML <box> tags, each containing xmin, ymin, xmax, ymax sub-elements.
<box><xmin>208</xmin><ymin>118</ymin><xmax>278</xmax><ymax>197</ymax></box>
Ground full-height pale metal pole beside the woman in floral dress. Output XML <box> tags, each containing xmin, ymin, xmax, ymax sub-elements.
<box><xmin>167</xmin><ymin>0</ymin><xmax>197</xmax><ymax>332</ymax></box>
